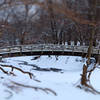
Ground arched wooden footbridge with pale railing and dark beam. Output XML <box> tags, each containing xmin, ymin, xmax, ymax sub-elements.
<box><xmin>0</xmin><ymin>44</ymin><xmax>100</xmax><ymax>56</ymax></box>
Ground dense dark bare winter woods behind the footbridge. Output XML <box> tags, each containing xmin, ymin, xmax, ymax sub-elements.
<box><xmin>0</xmin><ymin>0</ymin><xmax>100</xmax><ymax>46</ymax></box>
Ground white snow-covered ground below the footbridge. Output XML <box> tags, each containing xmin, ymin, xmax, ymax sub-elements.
<box><xmin>0</xmin><ymin>56</ymin><xmax>100</xmax><ymax>100</ymax></box>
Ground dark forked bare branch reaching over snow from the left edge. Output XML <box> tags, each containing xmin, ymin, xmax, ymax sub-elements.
<box><xmin>1</xmin><ymin>65</ymin><xmax>35</xmax><ymax>79</ymax></box>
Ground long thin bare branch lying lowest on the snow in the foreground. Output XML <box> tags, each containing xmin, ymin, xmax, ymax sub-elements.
<box><xmin>11</xmin><ymin>81</ymin><xmax>57</xmax><ymax>96</ymax></box>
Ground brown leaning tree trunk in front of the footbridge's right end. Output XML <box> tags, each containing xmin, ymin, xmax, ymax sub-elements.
<box><xmin>81</xmin><ymin>0</ymin><xmax>97</xmax><ymax>86</ymax></box>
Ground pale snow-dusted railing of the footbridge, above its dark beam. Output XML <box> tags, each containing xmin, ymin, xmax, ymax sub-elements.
<box><xmin>0</xmin><ymin>44</ymin><xmax>100</xmax><ymax>54</ymax></box>
